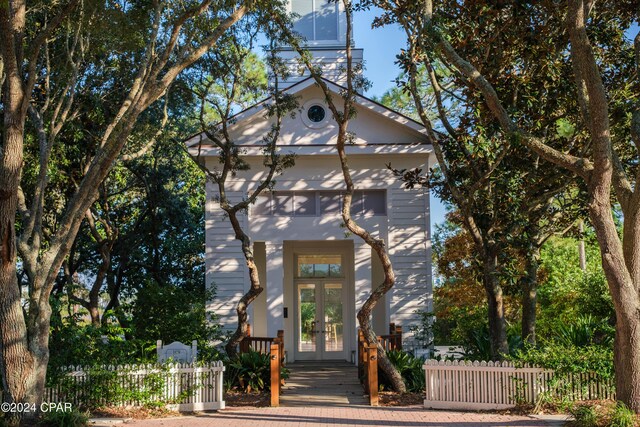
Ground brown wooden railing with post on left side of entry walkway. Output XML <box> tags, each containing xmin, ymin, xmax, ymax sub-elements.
<box><xmin>240</xmin><ymin>325</ymin><xmax>285</xmax><ymax>406</ymax></box>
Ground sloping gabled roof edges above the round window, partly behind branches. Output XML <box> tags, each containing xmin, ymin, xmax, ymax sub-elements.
<box><xmin>185</xmin><ymin>77</ymin><xmax>429</xmax><ymax>155</ymax></box>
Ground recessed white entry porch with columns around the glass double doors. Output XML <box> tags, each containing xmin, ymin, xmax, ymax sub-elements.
<box><xmin>250</xmin><ymin>239</ymin><xmax>389</xmax><ymax>363</ymax></box>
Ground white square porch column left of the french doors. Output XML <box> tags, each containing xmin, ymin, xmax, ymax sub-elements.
<box><xmin>265</xmin><ymin>242</ymin><xmax>284</xmax><ymax>337</ymax></box>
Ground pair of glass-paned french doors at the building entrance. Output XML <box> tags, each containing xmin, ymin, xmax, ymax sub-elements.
<box><xmin>296</xmin><ymin>279</ymin><xmax>346</xmax><ymax>360</ymax></box>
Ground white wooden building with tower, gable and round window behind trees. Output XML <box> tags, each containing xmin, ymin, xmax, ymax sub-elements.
<box><xmin>187</xmin><ymin>0</ymin><xmax>434</xmax><ymax>361</ymax></box>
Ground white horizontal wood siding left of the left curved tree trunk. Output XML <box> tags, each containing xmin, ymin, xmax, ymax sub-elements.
<box><xmin>205</xmin><ymin>183</ymin><xmax>248</xmax><ymax>329</ymax></box>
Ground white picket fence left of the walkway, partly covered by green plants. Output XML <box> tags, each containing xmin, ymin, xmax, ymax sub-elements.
<box><xmin>38</xmin><ymin>361</ymin><xmax>225</xmax><ymax>412</ymax></box>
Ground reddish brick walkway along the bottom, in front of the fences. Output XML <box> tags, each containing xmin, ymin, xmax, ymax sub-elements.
<box><xmin>126</xmin><ymin>406</ymin><xmax>552</xmax><ymax>427</ymax></box>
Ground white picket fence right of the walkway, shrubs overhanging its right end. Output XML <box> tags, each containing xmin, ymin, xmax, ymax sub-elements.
<box><xmin>423</xmin><ymin>360</ymin><xmax>614</xmax><ymax>410</ymax></box>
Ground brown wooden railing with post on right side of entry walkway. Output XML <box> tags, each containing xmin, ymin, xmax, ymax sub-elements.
<box><xmin>358</xmin><ymin>323</ymin><xmax>402</xmax><ymax>406</ymax></box>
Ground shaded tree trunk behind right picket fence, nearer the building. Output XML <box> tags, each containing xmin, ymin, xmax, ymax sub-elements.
<box><xmin>482</xmin><ymin>251</ymin><xmax>509</xmax><ymax>360</ymax></box>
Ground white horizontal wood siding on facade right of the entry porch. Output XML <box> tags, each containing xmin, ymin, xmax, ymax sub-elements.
<box><xmin>388</xmin><ymin>188</ymin><xmax>432</xmax><ymax>346</ymax></box>
